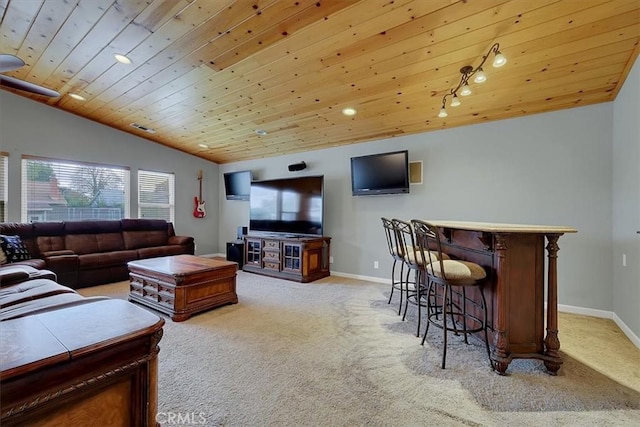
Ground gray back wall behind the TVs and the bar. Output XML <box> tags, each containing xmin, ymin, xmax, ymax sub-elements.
<box><xmin>219</xmin><ymin>103</ymin><xmax>613</xmax><ymax>311</ymax></box>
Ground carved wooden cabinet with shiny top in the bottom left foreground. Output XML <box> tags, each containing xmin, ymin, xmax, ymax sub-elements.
<box><xmin>0</xmin><ymin>299</ymin><xmax>164</xmax><ymax>427</ymax></box>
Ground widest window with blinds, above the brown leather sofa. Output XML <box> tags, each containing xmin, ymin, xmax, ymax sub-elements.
<box><xmin>22</xmin><ymin>156</ymin><xmax>129</xmax><ymax>222</ymax></box>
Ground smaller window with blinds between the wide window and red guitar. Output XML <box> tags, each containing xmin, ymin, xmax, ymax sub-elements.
<box><xmin>138</xmin><ymin>170</ymin><xmax>175</xmax><ymax>222</ymax></box>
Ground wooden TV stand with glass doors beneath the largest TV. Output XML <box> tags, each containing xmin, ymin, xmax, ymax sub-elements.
<box><xmin>242</xmin><ymin>234</ymin><xmax>331</xmax><ymax>283</ymax></box>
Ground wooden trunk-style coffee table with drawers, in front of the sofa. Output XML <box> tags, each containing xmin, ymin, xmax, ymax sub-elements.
<box><xmin>128</xmin><ymin>255</ymin><xmax>238</xmax><ymax>322</ymax></box>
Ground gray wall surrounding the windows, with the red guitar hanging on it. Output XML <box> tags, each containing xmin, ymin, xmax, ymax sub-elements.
<box><xmin>0</xmin><ymin>91</ymin><xmax>219</xmax><ymax>254</ymax></box>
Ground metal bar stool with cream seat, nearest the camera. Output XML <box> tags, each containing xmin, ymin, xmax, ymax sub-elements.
<box><xmin>411</xmin><ymin>219</ymin><xmax>494</xmax><ymax>369</ymax></box>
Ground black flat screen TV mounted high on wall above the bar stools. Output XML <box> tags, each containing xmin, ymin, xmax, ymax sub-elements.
<box><xmin>351</xmin><ymin>150</ymin><xmax>409</xmax><ymax>196</ymax></box>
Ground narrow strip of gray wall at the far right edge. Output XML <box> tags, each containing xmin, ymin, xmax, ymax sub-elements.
<box><xmin>613</xmin><ymin>56</ymin><xmax>640</xmax><ymax>335</ymax></box>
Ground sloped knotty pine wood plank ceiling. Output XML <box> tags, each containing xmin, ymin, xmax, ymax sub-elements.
<box><xmin>0</xmin><ymin>0</ymin><xmax>640</xmax><ymax>163</ymax></box>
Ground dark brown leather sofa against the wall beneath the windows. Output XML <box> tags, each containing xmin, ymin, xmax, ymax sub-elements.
<box><xmin>0</xmin><ymin>219</ymin><xmax>195</xmax><ymax>289</ymax></box>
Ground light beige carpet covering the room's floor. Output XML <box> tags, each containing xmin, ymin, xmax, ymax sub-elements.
<box><xmin>81</xmin><ymin>271</ymin><xmax>640</xmax><ymax>426</ymax></box>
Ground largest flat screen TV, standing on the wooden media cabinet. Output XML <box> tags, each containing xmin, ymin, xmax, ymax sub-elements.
<box><xmin>249</xmin><ymin>176</ymin><xmax>324</xmax><ymax>236</ymax></box>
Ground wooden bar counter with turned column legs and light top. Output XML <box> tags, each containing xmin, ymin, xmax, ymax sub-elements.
<box><xmin>426</xmin><ymin>220</ymin><xmax>577</xmax><ymax>375</ymax></box>
